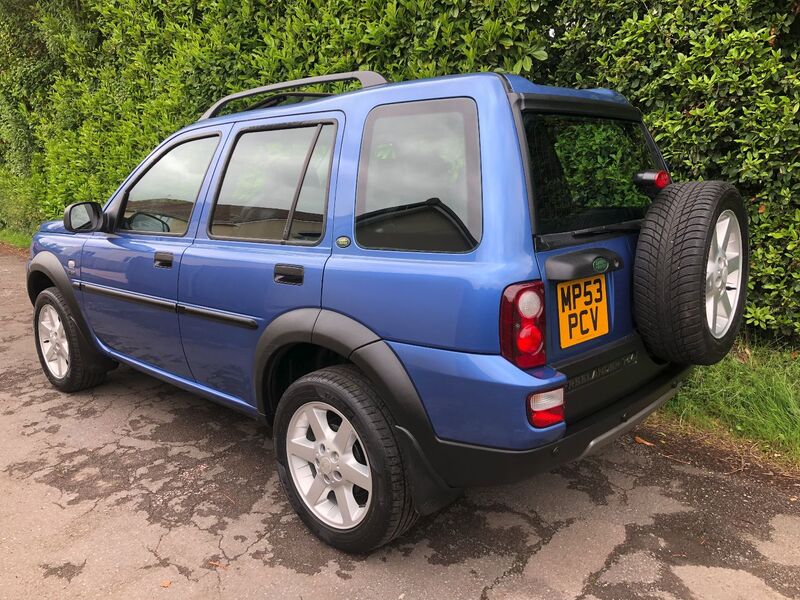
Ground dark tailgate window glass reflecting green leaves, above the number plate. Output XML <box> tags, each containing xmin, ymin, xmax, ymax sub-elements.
<box><xmin>523</xmin><ymin>111</ymin><xmax>659</xmax><ymax>234</ymax></box>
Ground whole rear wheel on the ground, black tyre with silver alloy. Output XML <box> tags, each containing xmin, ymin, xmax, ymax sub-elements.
<box><xmin>275</xmin><ymin>365</ymin><xmax>417</xmax><ymax>553</ymax></box>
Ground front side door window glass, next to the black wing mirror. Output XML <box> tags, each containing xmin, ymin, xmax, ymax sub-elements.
<box><xmin>119</xmin><ymin>136</ymin><xmax>218</xmax><ymax>235</ymax></box>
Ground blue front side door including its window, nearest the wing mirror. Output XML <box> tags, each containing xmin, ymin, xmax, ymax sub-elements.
<box><xmin>80</xmin><ymin>128</ymin><xmax>230</xmax><ymax>379</ymax></box>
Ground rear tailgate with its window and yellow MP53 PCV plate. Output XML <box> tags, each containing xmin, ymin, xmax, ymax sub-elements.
<box><xmin>522</xmin><ymin>104</ymin><xmax>667</xmax><ymax>423</ymax></box>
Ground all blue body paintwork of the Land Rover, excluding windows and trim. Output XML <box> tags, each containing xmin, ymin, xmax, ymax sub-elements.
<box><xmin>32</xmin><ymin>73</ymin><xmax>648</xmax><ymax>449</ymax></box>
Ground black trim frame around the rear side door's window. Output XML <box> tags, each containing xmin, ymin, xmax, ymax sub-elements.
<box><xmin>206</xmin><ymin>117</ymin><xmax>339</xmax><ymax>247</ymax></box>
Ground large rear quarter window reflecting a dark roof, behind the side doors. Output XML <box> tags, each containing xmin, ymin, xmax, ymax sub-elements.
<box><xmin>356</xmin><ymin>98</ymin><xmax>482</xmax><ymax>252</ymax></box>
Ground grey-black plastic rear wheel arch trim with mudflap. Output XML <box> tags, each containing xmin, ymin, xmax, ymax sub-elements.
<box><xmin>254</xmin><ymin>308</ymin><xmax>459</xmax><ymax>514</ymax></box>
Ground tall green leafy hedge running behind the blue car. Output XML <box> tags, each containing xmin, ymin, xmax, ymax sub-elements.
<box><xmin>0</xmin><ymin>0</ymin><xmax>800</xmax><ymax>335</ymax></box>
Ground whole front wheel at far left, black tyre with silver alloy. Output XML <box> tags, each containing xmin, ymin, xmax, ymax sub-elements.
<box><xmin>33</xmin><ymin>287</ymin><xmax>108</xmax><ymax>392</ymax></box>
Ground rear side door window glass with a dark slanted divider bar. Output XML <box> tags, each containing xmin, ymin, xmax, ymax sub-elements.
<box><xmin>211</xmin><ymin>124</ymin><xmax>335</xmax><ymax>243</ymax></box>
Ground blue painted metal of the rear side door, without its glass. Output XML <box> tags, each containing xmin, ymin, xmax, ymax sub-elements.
<box><xmin>179</xmin><ymin>111</ymin><xmax>344</xmax><ymax>405</ymax></box>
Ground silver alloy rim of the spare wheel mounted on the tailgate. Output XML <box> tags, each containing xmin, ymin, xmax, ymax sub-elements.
<box><xmin>706</xmin><ymin>210</ymin><xmax>742</xmax><ymax>339</ymax></box>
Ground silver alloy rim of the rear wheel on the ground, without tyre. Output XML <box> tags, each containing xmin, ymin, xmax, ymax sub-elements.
<box><xmin>286</xmin><ymin>402</ymin><xmax>372</xmax><ymax>529</ymax></box>
